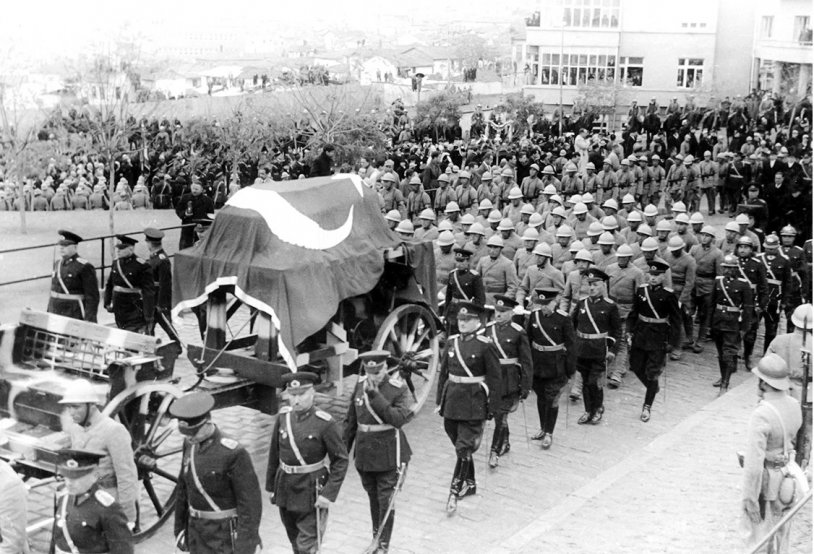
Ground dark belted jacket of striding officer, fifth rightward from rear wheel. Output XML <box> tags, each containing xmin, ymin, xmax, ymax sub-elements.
<box><xmin>627</xmin><ymin>285</ymin><xmax>681</xmax><ymax>350</ymax></box>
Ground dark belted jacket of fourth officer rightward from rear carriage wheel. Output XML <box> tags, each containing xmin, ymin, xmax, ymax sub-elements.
<box><xmin>571</xmin><ymin>296</ymin><xmax>622</xmax><ymax>359</ymax></box>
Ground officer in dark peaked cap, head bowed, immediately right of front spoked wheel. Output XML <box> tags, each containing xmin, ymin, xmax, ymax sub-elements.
<box><xmin>170</xmin><ymin>392</ymin><xmax>263</xmax><ymax>554</ymax></box>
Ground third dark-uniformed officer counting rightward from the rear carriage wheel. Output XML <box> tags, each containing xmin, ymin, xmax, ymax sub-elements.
<box><xmin>526</xmin><ymin>288</ymin><xmax>576</xmax><ymax>449</ymax></box>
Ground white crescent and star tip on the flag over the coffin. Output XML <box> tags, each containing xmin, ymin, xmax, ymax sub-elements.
<box><xmin>226</xmin><ymin>175</ymin><xmax>364</xmax><ymax>250</ymax></box>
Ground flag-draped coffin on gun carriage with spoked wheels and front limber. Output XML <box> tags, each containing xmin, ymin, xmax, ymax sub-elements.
<box><xmin>0</xmin><ymin>175</ymin><xmax>441</xmax><ymax>540</ymax></box>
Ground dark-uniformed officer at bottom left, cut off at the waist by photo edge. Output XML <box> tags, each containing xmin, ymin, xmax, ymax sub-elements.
<box><xmin>51</xmin><ymin>449</ymin><xmax>133</xmax><ymax>554</ymax></box>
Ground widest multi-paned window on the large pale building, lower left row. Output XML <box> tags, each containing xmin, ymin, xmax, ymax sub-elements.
<box><xmin>526</xmin><ymin>48</ymin><xmax>616</xmax><ymax>86</ymax></box>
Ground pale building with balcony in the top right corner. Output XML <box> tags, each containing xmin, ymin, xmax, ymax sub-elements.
<box><xmin>752</xmin><ymin>0</ymin><xmax>812</xmax><ymax>100</ymax></box>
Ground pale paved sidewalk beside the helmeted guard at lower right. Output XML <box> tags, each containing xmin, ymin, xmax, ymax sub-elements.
<box><xmin>500</xmin><ymin>379</ymin><xmax>811</xmax><ymax>553</ymax></box>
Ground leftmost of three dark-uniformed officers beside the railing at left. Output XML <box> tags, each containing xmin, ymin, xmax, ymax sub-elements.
<box><xmin>48</xmin><ymin>230</ymin><xmax>99</xmax><ymax>323</ymax></box>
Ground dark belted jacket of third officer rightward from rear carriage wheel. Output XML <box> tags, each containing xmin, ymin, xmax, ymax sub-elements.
<box><xmin>526</xmin><ymin>310</ymin><xmax>576</xmax><ymax>379</ymax></box>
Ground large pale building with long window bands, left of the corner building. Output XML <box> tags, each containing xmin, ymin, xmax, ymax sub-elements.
<box><xmin>512</xmin><ymin>0</ymin><xmax>754</xmax><ymax>111</ymax></box>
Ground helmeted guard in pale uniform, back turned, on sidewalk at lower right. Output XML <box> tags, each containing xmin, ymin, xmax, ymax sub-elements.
<box><xmin>742</xmin><ymin>354</ymin><xmax>802</xmax><ymax>552</ymax></box>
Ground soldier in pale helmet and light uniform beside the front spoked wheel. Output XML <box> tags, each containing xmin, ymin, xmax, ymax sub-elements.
<box><xmin>59</xmin><ymin>379</ymin><xmax>138</xmax><ymax>526</ymax></box>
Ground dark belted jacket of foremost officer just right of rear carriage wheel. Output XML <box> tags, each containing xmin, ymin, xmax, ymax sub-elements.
<box><xmin>435</xmin><ymin>333</ymin><xmax>503</xmax><ymax>421</ymax></box>
